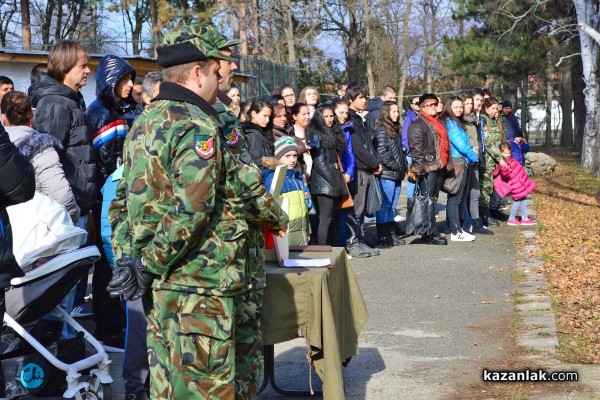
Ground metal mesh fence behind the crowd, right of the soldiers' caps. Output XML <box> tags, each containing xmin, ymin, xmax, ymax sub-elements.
<box><xmin>237</xmin><ymin>56</ymin><xmax>298</xmax><ymax>101</ymax></box>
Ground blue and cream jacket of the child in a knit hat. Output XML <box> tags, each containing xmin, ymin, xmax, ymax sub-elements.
<box><xmin>262</xmin><ymin>157</ymin><xmax>312</xmax><ymax>246</ymax></box>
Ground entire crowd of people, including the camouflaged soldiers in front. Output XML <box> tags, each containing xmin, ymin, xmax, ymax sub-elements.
<box><xmin>0</xmin><ymin>21</ymin><xmax>535</xmax><ymax>399</ymax></box>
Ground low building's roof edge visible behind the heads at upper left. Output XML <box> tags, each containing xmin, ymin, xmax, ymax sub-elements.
<box><xmin>0</xmin><ymin>48</ymin><xmax>252</xmax><ymax>83</ymax></box>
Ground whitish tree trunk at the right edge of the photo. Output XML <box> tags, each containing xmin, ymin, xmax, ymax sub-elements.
<box><xmin>575</xmin><ymin>19</ymin><xmax>600</xmax><ymax>176</ymax></box>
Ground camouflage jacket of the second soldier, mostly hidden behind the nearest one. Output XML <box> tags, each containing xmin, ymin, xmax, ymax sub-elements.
<box><xmin>213</xmin><ymin>93</ymin><xmax>288</xmax><ymax>289</ymax></box>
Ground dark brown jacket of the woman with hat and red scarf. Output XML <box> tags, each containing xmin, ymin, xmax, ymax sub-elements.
<box><xmin>408</xmin><ymin>116</ymin><xmax>454</xmax><ymax>175</ymax></box>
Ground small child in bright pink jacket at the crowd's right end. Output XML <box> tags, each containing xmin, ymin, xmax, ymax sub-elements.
<box><xmin>494</xmin><ymin>142</ymin><xmax>537</xmax><ymax>225</ymax></box>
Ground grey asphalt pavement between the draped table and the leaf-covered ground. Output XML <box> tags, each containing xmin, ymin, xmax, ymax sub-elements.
<box><xmin>255</xmin><ymin>192</ymin><xmax>600</xmax><ymax>399</ymax></box>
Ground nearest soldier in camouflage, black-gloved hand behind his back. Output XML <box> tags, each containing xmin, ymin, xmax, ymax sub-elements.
<box><xmin>108</xmin><ymin>25</ymin><xmax>287</xmax><ymax>399</ymax></box>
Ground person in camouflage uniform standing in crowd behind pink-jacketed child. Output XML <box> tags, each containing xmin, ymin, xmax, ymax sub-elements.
<box><xmin>479</xmin><ymin>98</ymin><xmax>504</xmax><ymax>213</ymax></box>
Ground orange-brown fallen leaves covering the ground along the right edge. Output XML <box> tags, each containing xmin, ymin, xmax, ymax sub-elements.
<box><xmin>534</xmin><ymin>156</ymin><xmax>600</xmax><ymax>364</ymax></box>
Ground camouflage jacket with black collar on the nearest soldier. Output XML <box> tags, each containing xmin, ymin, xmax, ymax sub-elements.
<box><xmin>109</xmin><ymin>82</ymin><xmax>251</xmax><ymax>296</ymax></box>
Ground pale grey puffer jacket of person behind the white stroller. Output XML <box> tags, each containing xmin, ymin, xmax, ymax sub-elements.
<box><xmin>6</xmin><ymin>126</ymin><xmax>81</xmax><ymax>223</ymax></box>
